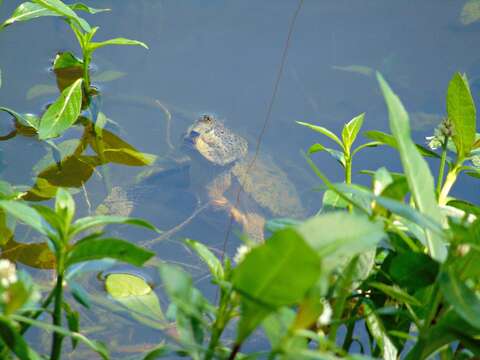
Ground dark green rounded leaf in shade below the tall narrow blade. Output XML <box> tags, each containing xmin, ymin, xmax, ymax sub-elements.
<box><xmin>388</xmin><ymin>251</ymin><xmax>439</xmax><ymax>291</ymax></box>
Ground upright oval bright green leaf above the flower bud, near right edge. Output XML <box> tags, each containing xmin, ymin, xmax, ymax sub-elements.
<box><xmin>447</xmin><ymin>73</ymin><xmax>476</xmax><ymax>159</ymax></box>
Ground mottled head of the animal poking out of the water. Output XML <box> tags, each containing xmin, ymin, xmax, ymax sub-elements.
<box><xmin>183</xmin><ymin>115</ymin><xmax>247</xmax><ymax>166</ymax></box>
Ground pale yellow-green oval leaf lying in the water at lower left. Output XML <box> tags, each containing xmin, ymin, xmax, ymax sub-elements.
<box><xmin>105</xmin><ymin>273</ymin><xmax>165</xmax><ymax>329</ymax></box>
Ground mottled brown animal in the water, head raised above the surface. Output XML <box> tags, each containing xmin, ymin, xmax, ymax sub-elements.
<box><xmin>183</xmin><ymin>115</ymin><xmax>304</xmax><ymax>241</ymax></box>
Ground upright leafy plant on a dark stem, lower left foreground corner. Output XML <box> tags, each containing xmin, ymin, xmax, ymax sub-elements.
<box><xmin>0</xmin><ymin>188</ymin><xmax>156</xmax><ymax>359</ymax></box>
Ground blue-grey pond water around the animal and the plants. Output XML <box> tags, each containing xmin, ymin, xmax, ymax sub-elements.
<box><xmin>0</xmin><ymin>0</ymin><xmax>480</xmax><ymax>358</ymax></box>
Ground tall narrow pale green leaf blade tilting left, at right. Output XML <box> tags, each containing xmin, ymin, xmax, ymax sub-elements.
<box><xmin>377</xmin><ymin>73</ymin><xmax>447</xmax><ymax>261</ymax></box>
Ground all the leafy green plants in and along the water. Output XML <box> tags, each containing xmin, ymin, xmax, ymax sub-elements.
<box><xmin>0</xmin><ymin>0</ymin><xmax>480</xmax><ymax>360</ymax></box>
